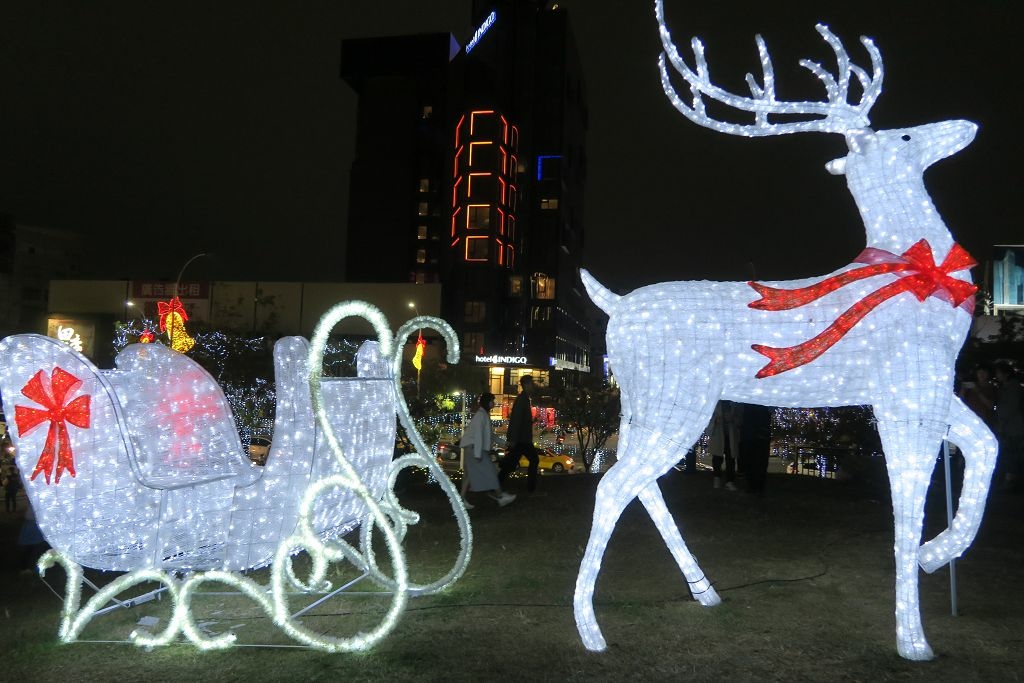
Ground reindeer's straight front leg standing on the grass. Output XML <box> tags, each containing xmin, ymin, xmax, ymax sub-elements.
<box><xmin>876</xmin><ymin>417</ymin><xmax>945</xmax><ymax>660</ymax></box>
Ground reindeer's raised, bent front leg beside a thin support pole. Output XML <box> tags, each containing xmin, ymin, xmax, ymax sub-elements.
<box><xmin>920</xmin><ymin>396</ymin><xmax>996</xmax><ymax>573</ymax></box>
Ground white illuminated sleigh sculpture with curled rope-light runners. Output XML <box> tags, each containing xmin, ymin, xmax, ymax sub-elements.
<box><xmin>0</xmin><ymin>302</ymin><xmax>472</xmax><ymax>650</ymax></box>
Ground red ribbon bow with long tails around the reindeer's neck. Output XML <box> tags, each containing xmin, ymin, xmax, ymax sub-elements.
<box><xmin>748</xmin><ymin>240</ymin><xmax>978</xmax><ymax>379</ymax></box>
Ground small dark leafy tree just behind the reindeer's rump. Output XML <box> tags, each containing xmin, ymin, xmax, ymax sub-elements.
<box><xmin>552</xmin><ymin>376</ymin><xmax>622</xmax><ymax>472</ymax></box>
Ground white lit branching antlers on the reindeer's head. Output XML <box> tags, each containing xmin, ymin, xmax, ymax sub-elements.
<box><xmin>654</xmin><ymin>0</ymin><xmax>883</xmax><ymax>136</ymax></box>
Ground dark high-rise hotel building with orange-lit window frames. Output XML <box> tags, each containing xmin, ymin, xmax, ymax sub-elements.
<box><xmin>342</xmin><ymin>0</ymin><xmax>591</xmax><ymax>394</ymax></box>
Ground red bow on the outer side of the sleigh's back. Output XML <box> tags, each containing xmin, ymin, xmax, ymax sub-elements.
<box><xmin>14</xmin><ymin>366</ymin><xmax>89</xmax><ymax>484</ymax></box>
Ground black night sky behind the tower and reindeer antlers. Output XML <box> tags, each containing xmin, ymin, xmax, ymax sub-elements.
<box><xmin>0</xmin><ymin>0</ymin><xmax>1024</xmax><ymax>290</ymax></box>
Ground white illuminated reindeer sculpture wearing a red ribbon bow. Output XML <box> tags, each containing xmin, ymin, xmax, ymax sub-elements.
<box><xmin>574</xmin><ymin>0</ymin><xmax>995</xmax><ymax>659</ymax></box>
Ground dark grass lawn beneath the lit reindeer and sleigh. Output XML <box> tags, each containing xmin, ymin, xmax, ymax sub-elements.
<box><xmin>0</xmin><ymin>471</ymin><xmax>1024</xmax><ymax>683</ymax></box>
